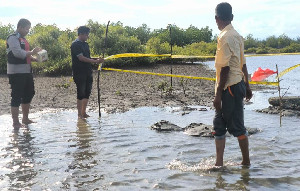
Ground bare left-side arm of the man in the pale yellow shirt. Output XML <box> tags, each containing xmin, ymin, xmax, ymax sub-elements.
<box><xmin>214</xmin><ymin>66</ymin><xmax>230</xmax><ymax>112</ymax></box>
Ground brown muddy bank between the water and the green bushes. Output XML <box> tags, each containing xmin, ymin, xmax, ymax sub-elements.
<box><xmin>0</xmin><ymin>64</ymin><xmax>215</xmax><ymax>115</ymax></box>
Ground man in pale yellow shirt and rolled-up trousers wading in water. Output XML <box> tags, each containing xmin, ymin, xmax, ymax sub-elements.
<box><xmin>213</xmin><ymin>3</ymin><xmax>252</xmax><ymax>166</ymax></box>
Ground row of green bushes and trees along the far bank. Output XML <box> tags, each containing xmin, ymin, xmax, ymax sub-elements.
<box><xmin>0</xmin><ymin>20</ymin><xmax>300</xmax><ymax>75</ymax></box>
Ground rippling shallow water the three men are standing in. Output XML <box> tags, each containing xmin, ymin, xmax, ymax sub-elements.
<box><xmin>0</xmin><ymin>54</ymin><xmax>300</xmax><ymax>190</ymax></box>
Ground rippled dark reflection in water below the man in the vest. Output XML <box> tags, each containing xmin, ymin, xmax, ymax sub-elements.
<box><xmin>4</xmin><ymin>128</ymin><xmax>37</xmax><ymax>190</ymax></box>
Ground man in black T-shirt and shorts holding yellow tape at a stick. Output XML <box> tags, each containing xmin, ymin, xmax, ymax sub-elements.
<box><xmin>71</xmin><ymin>26</ymin><xmax>104</xmax><ymax>118</ymax></box>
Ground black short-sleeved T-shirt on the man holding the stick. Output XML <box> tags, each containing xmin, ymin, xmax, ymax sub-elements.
<box><xmin>71</xmin><ymin>39</ymin><xmax>92</xmax><ymax>75</ymax></box>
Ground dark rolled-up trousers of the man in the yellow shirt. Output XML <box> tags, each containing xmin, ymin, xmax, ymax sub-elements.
<box><xmin>213</xmin><ymin>81</ymin><xmax>247</xmax><ymax>138</ymax></box>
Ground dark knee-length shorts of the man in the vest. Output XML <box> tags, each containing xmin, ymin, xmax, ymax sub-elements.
<box><xmin>8</xmin><ymin>73</ymin><xmax>35</xmax><ymax>107</ymax></box>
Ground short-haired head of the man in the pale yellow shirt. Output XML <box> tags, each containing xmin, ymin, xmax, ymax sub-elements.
<box><xmin>215</xmin><ymin>2</ymin><xmax>233</xmax><ymax>30</ymax></box>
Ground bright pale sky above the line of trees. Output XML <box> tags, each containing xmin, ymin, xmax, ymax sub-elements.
<box><xmin>0</xmin><ymin>0</ymin><xmax>300</xmax><ymax>40</ymax></box>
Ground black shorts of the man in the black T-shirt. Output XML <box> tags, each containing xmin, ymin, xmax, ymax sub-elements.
<box><xmin>73</xmin><ymin>72</ymin><xmax>93</xmax><ymax>100</ymax></box>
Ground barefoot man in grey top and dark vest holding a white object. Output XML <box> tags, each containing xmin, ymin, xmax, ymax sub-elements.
<box><xmin>6</xmin><ymin>19</ymin><xmax>41</xmax><ymax>129</ymax></box>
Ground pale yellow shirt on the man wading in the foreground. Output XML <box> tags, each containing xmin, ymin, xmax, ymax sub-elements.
<box><xmin>215</xmin><ymin>24</ymin><xmax>246</xmax><ymax>92</ymax></box>
